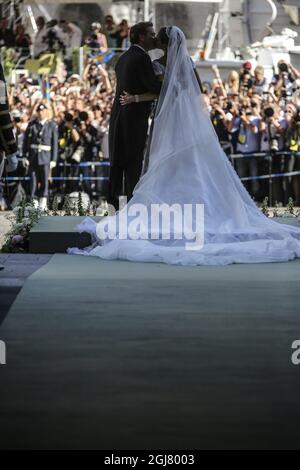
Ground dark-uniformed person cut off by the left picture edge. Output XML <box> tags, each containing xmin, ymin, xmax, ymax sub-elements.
<box><xmin>0</xmin><ymin>60</ymin><xmax>18</xmax><ymax>270</ymax></box>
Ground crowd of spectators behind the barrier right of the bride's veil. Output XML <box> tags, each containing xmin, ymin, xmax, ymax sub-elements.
<box><xmin>203</xmin><ymin>60</ymin><xmax>300</xmax><ymax>205</ymax></box>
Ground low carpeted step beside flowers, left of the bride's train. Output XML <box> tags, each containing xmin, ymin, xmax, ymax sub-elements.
<box><xmin>29</xmin><ymin>216</ymin><xmax>102</xmax><ymax>253</ymax></box>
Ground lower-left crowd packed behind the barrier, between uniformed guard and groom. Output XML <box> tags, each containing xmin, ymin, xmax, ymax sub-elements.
<box><xmin>2</xmin><ymin>59</ymin><xmax>115</xmax><ymax>207</ymax></box>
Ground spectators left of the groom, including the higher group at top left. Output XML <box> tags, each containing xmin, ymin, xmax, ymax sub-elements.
<box><xmin>0</xmin><ymin>15</ymin><xmax>129</xmax><ymax>207</ymax></box>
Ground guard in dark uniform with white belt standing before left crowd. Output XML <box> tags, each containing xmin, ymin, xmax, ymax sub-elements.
<box><xmin>23</xmin><ymin>104</ymin><xmax>58</xmax><ymax>209</ymax></box>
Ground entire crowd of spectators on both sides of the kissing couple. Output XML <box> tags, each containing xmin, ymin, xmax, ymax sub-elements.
<box><xmin>0</xmin><ymin>10</ymin><xmax>300</xmax><ymax>205</ymax></box>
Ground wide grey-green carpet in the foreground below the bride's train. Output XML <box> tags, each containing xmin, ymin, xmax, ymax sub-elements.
<box><xmin>0</xmin><ymin>254</ymin><xmax>300</xmax><ymax>449</ymax></box>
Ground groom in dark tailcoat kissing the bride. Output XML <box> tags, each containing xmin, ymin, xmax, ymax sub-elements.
<box><xmin>108</xmin><ymin>22</ymin><xmax>161</xmax><ymax>209</ymax></box>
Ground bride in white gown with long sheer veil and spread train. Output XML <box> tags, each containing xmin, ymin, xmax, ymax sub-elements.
<box><xmin>68</xmin><ymin>26</ymin><xmax>300</xmax><ymax>265</ymax></box>
